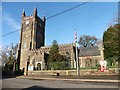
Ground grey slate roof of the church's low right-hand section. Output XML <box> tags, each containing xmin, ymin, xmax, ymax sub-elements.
<box><xmin>79</xmin><ymin>46</ymin><xmax>100</xmax><ymax>57</ymax></box>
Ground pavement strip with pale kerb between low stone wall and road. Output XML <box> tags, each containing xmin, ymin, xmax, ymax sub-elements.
<box><xmin>16</xmin><ymin>75</ymin><xmax>120</xmax><ymax>83</ymax></box>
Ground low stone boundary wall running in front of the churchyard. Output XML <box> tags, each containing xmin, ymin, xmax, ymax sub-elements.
<box><xmin>28</xmin><ymin>70</ymin><xmax>117</xmax><ymax>76</ymax></box>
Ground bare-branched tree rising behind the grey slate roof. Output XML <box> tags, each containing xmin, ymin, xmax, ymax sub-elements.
<box><xmin>78</xmin><ymin>35</ymin><xmax>98</xmax><ymax>47</ymax></box>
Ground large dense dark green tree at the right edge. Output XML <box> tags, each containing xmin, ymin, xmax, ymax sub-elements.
<box><xmin>103</xmin><ymin>24</ymin><xmax>120</xmax><ymax>66</ymax></box>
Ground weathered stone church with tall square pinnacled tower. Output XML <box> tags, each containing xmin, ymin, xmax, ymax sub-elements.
<box><xmin>16</xmin><ymin>8</ymin><xmax>103</xmax><ymax>75</ymax></box>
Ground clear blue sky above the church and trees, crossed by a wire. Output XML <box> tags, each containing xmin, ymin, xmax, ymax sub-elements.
<box><xmin>2</xmin><ymin>2</ymin><xmax>118</xmax><ymax>46</ymax></box>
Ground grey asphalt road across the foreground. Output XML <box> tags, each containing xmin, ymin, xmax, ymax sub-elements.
<box><xmin>2</xmin><ymin>78</ymin><xmax>118</xmax><ymax>90</ymax></box>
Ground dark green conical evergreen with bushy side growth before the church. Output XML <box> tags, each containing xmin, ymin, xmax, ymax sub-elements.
<box><xmin>47</xmin><ymin>40</ymin><xmax>70</xmax><ymax>70</ymax></box>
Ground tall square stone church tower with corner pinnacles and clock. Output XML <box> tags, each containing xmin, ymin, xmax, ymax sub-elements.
<box><xmin>17</xmin><ymin>8</ymin><xmax>46</xmax><ymax>75</ymax></box>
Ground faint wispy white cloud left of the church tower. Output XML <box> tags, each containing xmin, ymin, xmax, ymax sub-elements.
<box><xmin>3</xmin><ymin>14</ymin><xmax>20</xmax><ymax>30</ymax></box>
